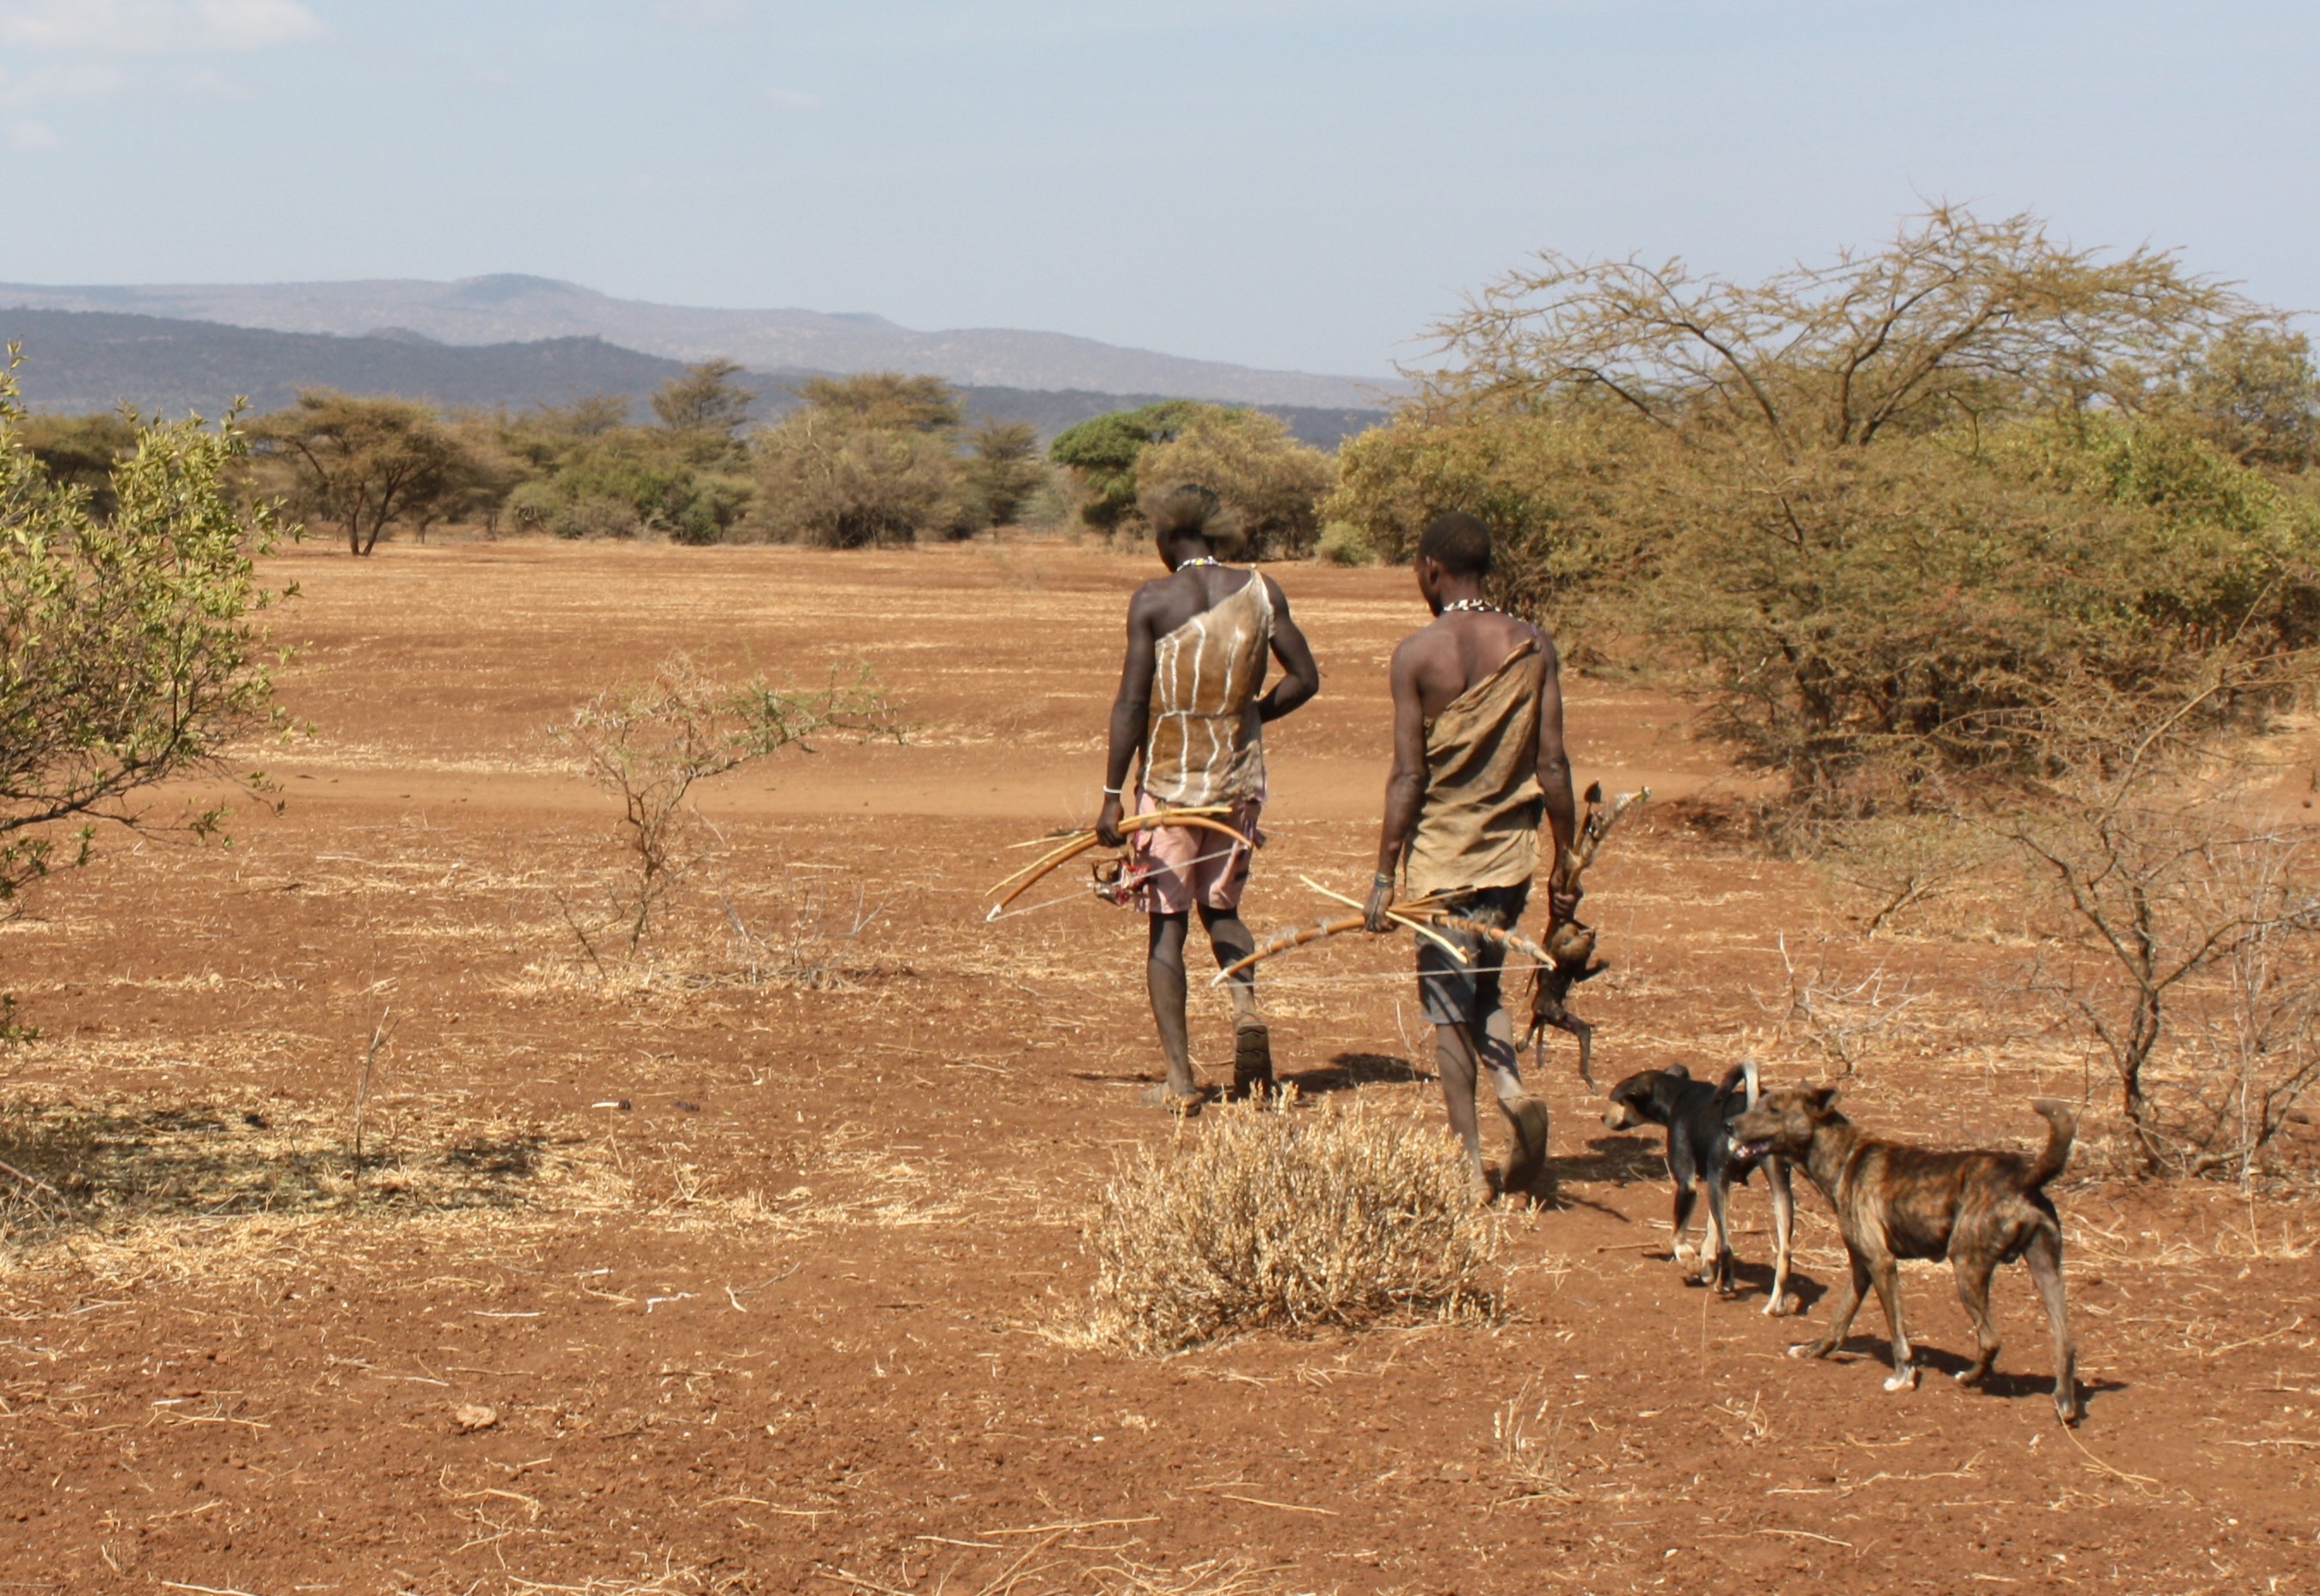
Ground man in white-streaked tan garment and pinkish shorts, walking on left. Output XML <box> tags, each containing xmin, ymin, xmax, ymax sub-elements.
<box><xmin>1095</xmin><ymin>488</ymin><xmax>1320</xmax><ymax>1111</ymax></box>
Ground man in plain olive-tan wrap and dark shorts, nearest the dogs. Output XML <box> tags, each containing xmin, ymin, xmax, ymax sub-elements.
<box><xmin>1369</xmin><ymin>515</ymin><xmax>1578</xmax><ymax>1197</ymax></box>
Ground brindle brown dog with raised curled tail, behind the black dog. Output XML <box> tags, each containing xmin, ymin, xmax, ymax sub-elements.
<box><xmin>1731</xmin><ymin>1086</ymin><xmax>2084</xmax><ymax>1424</ymax></box>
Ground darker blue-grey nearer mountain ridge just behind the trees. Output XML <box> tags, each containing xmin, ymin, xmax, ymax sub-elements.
<box><xmin>0</xmin><ymin>309</ymin><xmax>1385</xmax><ymax>448</ymax></box>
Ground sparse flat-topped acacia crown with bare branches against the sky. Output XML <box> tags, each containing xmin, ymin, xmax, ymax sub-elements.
<box><xmin>1433</xmin><ymin>204</ymin><xmax>2255</xmax><ymax>459</ymax></box>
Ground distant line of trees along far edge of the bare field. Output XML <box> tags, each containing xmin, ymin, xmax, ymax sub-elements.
<box><xmin>19</xmin><ymin>359</ymin><xmax>1334</xmax><ymax>556</ymax></box>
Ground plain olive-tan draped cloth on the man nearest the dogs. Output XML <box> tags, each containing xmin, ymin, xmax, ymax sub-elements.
<box><xmin>1402</xmin><ymin>642</ymin><xmax>1548</xmax><ymax>898</ymax></box>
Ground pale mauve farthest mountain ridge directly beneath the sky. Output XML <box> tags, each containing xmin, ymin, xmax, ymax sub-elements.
<box><xmin>0</xmin><ymin>273</ymin><xmax>1399</xmax><ymax>408</ymax></box>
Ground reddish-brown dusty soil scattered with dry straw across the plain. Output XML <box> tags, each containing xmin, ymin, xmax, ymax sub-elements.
<box><xmin>0</xmin><ymin>545</ymin><xmax>2320</xmax><ymax>1596</ymax></box>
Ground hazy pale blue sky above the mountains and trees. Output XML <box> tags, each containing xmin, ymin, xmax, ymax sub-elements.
<box><xmin>0</xmin><ymin>0</ymin><xmax>2320</xmax><ymax>376</ymax></box>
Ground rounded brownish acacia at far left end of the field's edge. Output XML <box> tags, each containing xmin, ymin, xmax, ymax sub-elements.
<box><xmin>250</xmin><ymin>388</ymin><xmax>464</xmax><ymax>555</ymax></box>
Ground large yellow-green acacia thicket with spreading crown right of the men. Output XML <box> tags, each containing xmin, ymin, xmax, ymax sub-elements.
<box><xmin>1364</xmin><ymin>206</ymin><xmax>2320</xmax><ymax>816</ymax></box>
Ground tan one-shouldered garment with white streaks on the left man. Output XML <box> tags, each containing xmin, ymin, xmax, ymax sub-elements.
<box><xmin>1144</xmin><ymin>571</ymin><xmax>1274</xmax><ymax>807</ymax></box>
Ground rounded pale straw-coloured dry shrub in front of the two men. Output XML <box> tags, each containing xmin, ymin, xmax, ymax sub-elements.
<box><xmin>1093</xmin><ymin>1097</ymin><xmax>1501</xmax><ymax>1354</ymax></box>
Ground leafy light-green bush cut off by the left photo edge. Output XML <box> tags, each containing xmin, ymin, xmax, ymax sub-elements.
<box><xmin>0</xmin><ymin>359</ymin><xmax>295</xmax><ymax>900</ymax></box>
